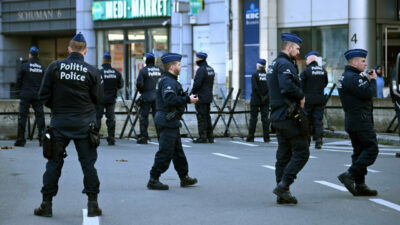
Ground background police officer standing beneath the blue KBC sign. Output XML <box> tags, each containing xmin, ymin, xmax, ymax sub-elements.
<box><xmin>246</xmin><ymin>59</ymin><xmax>270</xmax><ymax>142</ymax></box>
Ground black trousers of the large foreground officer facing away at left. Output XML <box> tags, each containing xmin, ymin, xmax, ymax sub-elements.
<box><xmin>41</xmin><ymin>131</ymin><xmax>100</xmax><ymax>196</ymax></box>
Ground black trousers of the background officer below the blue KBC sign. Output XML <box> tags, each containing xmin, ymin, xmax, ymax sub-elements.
<box><xmin>248</xmin><ymin>105</ymin><xmax>269</xmax><ymax>137</ymax></box>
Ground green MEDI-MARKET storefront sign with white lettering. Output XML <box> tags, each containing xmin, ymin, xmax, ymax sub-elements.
<box><xmin>92</xmin><ymin>0</ymin><xmax>171</xmax><ymax>21</ymax></box>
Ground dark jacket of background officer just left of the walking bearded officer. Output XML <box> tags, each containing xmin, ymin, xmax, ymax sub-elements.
<box><xmin>136</xmin><ymin>64</ymin><xmax>162</xmax><ymax>102</ymax></box>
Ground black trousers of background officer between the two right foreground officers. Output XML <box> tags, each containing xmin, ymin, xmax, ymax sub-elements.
<box><xmin>304</xmin><ymin>103</ymin><xmax>324</xmax><ymax>139</ymax></box>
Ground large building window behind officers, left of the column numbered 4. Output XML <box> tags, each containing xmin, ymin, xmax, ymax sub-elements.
<box><xmin>278</xmin><ymin>26</ymin><xmax>348</xmax><ymax>95</ymax></box>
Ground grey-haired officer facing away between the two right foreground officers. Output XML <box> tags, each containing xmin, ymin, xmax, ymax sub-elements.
<box><xmin>300</xmin><ymin>51</ymin><xmax>328</xmax><ymax>149</ymax></box>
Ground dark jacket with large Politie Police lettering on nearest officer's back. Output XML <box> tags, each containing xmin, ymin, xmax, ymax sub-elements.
<box><xmin>39</xmin><ymin>52</ymin><xmax>103</xmax><ymax>138</ymax></box>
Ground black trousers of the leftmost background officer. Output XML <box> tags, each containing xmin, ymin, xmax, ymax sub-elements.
<box><xmin>18</xmin><ymin>99</ymin><xmax>45</xmax><ymax>140</ymax></box>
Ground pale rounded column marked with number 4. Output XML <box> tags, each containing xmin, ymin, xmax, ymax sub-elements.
<box><xmin>348</xmin><ymin>0</ymin><xmax>376</xmax><ymax>68</ymax></box>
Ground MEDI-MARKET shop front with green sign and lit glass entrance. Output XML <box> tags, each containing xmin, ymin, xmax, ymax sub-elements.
<box><xmin>92</xmin><ymin>0</ymin><xmax>171</xmax><ymax>99</ymax></box>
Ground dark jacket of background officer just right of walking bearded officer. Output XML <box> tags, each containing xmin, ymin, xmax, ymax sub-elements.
<box><xmin>192</xmin><ymin>60</ymin><xmax>215</xmax><ymax>103</ymax></box>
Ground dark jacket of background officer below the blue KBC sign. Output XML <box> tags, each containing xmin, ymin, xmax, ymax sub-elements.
<box><xmin>250</xmin><ymin>69</ymin><xmax>268</xmax><ymax>105</ymax></box>
